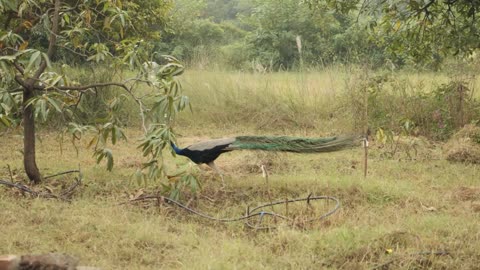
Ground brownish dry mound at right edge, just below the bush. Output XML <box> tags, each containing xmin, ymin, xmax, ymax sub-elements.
<box><xmin>444</xmin><ymin>125</ymin><xmax>480</xmax><ymax>164</ymax></box>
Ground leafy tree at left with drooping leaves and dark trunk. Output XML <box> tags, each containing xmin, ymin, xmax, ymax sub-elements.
<box><xmin>0</xmin><ymin>0</ymin><xmax>199</xmax><ymax>197</ymax></box>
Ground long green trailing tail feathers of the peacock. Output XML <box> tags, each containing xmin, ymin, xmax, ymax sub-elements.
<box><xmin>228</xmin><ymin>136</ymin><xmax>359</xmax><ymax>153</ymax></box>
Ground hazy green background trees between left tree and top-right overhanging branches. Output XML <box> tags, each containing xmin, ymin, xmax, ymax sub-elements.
<box><xmin>161</xmin><ymin>0</ymin><xmax>381</xmax><ymax>70</ymax></box>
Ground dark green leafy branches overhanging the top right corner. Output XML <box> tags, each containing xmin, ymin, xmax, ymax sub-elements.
<box><xmin>303</xmin><ymin>0</ymin><xmax>480</xmax><ymax>67</ymax></box>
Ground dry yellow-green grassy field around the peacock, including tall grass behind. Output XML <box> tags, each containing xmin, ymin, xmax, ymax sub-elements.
<box><xmin>0</xmin><ymin>69</ymin><xmax>480</xmax><ymax>269</ymax></box>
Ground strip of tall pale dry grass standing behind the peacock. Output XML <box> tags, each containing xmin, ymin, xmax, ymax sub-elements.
<box><xmin>174</xmin><ymin>66</ymin><xmax>480</xmax><ymax>136</ymax></box>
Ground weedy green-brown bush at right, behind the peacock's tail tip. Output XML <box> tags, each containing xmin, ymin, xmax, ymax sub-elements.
<box><xmin>345</xmin><ymin>74</ymin><xmax>480</xmax><ymax>140</ymax></box>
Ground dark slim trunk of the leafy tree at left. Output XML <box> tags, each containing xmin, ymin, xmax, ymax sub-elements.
<box><xmin>23</xmin><ymin>88</ymin><xmax>42</xmax><ymax>184</ymax></box>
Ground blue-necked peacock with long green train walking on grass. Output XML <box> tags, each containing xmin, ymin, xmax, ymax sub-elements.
<box><xmin>171</xmin><ymin>136</ymin><xmax>360</xmax><ymax>180</ymax></box>
